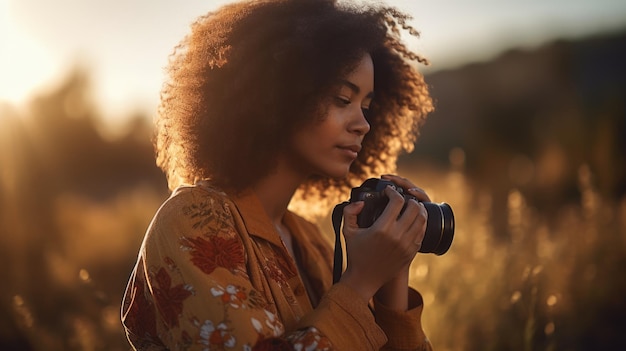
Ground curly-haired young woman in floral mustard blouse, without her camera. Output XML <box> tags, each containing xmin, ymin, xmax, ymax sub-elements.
<box><xmin>122</xmin><ymin>0</ymin><xmax>432</xmax><ymax>350</ymax></box>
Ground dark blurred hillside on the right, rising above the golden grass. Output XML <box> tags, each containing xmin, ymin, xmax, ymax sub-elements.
<box><xmin>408</xmin><ymin>30</ymin><xmax>626</xmax><ymax>214</ymax></box>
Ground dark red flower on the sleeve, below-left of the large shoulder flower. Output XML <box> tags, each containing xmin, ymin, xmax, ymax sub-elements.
<box><xmin>153</xmin><ymin>267</ymin><xmax>191</xmax><ymax>327</ymax></box>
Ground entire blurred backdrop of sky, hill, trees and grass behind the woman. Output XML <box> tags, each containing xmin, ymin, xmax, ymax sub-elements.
<box><xmin>0</xmin><ymin>0</ymin><xmax>626</xmax><ymax>350</ymax></box>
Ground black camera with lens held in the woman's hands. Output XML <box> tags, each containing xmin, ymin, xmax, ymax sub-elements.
<box><xmin>350</xmin><ymin>178</ymin><xmax>454</xmax><ymax>255</ymax></box>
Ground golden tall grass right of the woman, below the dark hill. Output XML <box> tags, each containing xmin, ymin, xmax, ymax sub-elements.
<box><xmin>400</xmin><ymin>165</ymin><xmax>626</xmax><ymax>351</ymax></box>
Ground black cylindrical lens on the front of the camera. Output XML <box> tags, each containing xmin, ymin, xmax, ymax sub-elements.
<box><xmin>419</xmin><ymin>202</ymin><xmax>454</xmax><ymax>256</ymax></box>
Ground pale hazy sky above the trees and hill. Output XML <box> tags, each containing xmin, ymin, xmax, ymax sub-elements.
<box><xmin>0</xmin><ymin>0</ymin><xmax>626</xmax><ymax>123</ymax></box>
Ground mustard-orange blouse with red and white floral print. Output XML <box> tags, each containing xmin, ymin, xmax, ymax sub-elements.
<box><xmin>122</xmin><ymin>182</ymin><xmax>431</xmax><ymax>351</ymax></box>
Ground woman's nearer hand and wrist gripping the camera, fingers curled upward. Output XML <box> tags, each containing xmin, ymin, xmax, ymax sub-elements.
<box><xmin>340</xmin><ymin>187</ymin><xmax>427</xmax><ymax>300</ymax></box>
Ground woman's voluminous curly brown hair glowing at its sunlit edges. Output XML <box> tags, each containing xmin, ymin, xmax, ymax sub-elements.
<box><xmin>155</xmin><ymin>0</ymin><xmax>433</xmax><ymax>212</ymax></box>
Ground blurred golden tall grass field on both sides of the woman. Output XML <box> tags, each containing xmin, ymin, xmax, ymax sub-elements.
<box><xmin>0</xmin><ymin>150</ymin><xmax>626</xmax><ymax>351</ymax></box>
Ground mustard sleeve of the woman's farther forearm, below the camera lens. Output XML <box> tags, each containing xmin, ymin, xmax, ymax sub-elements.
<box><xmin>374</xmin><ymin>288</ymin><xmax>432</xmax><ymax>351</ymax></box>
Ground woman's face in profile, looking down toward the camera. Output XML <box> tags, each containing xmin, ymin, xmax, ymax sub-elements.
<box><xmin>287</xmin><ymin>54</ymin><xmax>374</xmax><ymax>178</ymax></box>
